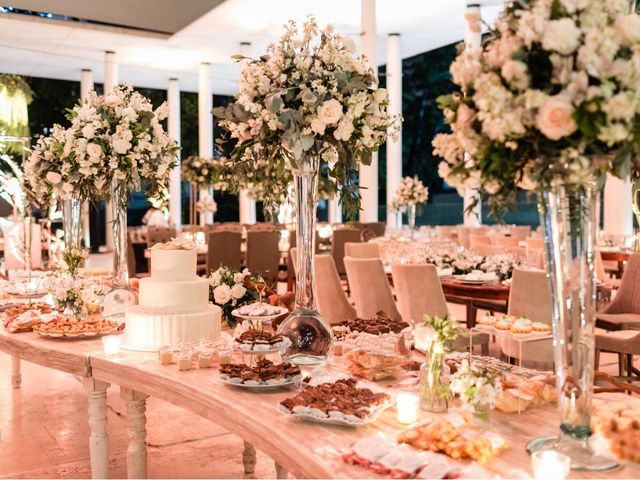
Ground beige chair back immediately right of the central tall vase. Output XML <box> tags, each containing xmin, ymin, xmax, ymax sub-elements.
<box><xmin>316</xmin><ymin>255</ymin><xmax>357</xmax><ymax>325</ymax></box>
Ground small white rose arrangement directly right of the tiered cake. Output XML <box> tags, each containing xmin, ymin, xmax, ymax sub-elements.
<box><xmin>209</xmin><ymin>266</ymin><xmax>259</xmax><ymax>327</ymax></box>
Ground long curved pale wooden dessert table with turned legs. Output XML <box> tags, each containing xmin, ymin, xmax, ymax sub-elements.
<box><xmin>0</xmin><ymin>332</ymin><xmax>640</xmax><ymax>478</ymax></box>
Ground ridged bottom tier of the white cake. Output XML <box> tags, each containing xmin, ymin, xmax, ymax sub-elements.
<box><xmin>122</xmin><ymin>305</ymin><xmax>222</xmax><ymax>352</ymax></box>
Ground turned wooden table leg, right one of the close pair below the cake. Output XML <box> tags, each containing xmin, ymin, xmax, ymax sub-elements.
<box><xmin>120</xmin><ymin>387</ymin><xmax>148</xmax><ymax>478</ymax></box>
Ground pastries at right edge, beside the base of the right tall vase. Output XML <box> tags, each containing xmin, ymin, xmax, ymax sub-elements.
<box><xmin>591</xmin><ymin>399</ymin><xmax>640</xmax><ymax>463</ymax></box>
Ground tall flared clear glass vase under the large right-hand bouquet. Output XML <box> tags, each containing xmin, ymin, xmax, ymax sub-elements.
<box><xmin>527</xmin><ymin>182</ymin><xmax>616</xmax><ymax>470</ymax></box>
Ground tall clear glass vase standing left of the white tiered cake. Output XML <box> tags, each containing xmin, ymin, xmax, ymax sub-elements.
<box><xmin>103</xmin><ymin>182</ymin><xmax>138</xmax><ymax>317</ymax></box>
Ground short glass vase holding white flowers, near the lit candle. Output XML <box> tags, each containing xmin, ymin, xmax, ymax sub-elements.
<box><xmin>413</xmin><ymin>315</ymin><xmax>459</xmax><ymax>412</ymax></box>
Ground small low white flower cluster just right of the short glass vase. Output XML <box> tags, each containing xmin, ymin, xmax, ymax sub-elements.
<box><xmin>449</xmin><ymin>359</ymin><xmax>502</xmax><ymax>420</ymax></box>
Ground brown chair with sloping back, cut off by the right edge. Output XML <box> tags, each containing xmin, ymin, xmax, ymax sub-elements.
<box><xmin>596</xmin><ymin>254</ymin><xmax>640</xmax><ymax>330</ymax></box>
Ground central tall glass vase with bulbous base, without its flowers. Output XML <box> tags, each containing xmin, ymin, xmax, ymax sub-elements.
<box><xmin>278</xmin><ymin>156</ymin><xmax>333</xmax><ymax>365</ymax></box>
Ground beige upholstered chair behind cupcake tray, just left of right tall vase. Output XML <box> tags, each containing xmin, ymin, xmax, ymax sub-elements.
<box><xmin>498</xmin><ymin>270</ymin><xmax>553</xmax><ymax>362</ymax></box>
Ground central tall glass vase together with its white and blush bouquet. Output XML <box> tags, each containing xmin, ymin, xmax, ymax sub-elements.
<box><xmin>214</xmin><ymin>17</ymin><xmax>396</xmax><ymax>363</ymax></box>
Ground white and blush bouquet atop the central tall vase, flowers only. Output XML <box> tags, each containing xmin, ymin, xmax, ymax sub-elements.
<box><xmin>214</xmin><ymin>17</ymin><xmax>398</xmax><ymax>215</ymax></box>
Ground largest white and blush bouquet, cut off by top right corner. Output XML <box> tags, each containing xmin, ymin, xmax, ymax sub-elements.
<box><xmin>433</xmin><ymin>0</ymin><xmax>640</xmax><ymax>213</ymax></box>
